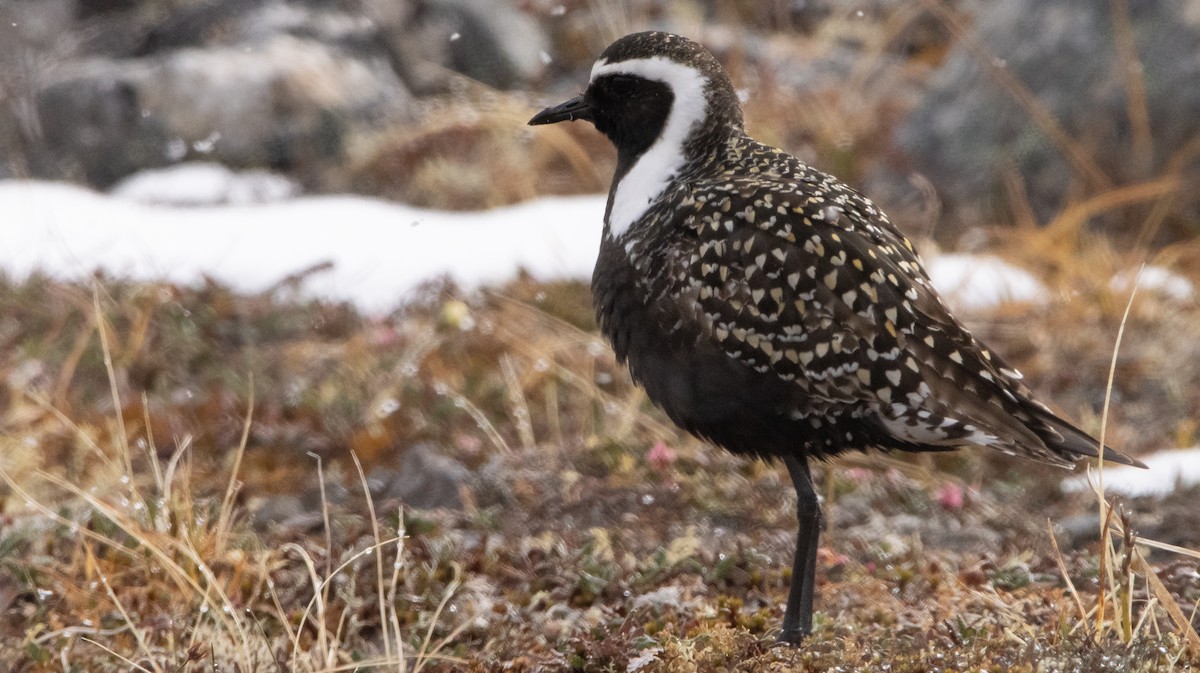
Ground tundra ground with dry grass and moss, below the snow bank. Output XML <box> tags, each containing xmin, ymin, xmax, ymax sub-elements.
<box><xmin>0</xmin><ymin>269</ymin><xmax>1200</xmax><ymax>672</ymax></box>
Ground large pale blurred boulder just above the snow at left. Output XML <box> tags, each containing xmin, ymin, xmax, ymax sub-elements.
<box><xmin>37</xmin><ymin>30</ymin><xmax>409</xmax><ymax>187</ymax></box>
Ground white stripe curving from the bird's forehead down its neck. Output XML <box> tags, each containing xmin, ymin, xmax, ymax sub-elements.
<box><xmin>592</xmin><ymin>56</ymin><xmax>708</xmax><ymax>239</ymax></box>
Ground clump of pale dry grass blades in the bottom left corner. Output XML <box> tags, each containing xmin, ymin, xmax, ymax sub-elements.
<box><xmin>0</xmin><ymin>285</ymin><xmax>464</xmax><ymax>672</ymax></box>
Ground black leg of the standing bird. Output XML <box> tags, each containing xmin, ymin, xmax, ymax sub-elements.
<box><xmin>779</xmin><ymin>456</ymin><xmax>821</xmax><ymax>645</ymax></box>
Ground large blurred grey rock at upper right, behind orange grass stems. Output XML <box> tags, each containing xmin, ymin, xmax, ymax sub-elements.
<box><xmin>894</xmin><ymin>0</ymin><xmax>1200</xmax><ymax>240</ymax></box>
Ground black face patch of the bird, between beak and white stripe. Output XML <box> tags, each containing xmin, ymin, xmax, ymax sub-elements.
<box><xmin>583</xmin><ymin>74</ymin><xmax>674</xmax><ymax>157</ymax></box>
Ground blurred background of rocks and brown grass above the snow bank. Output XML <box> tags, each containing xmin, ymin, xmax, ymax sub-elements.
<box><xmin>0</xmin><ymin>0</ymin><xmax>1200</xmax><ymax>241</ymax></box>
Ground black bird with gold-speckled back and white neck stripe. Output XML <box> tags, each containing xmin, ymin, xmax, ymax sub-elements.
<box><xmin>528</xmin><ymin>31</ymin><xmax>1145</xmax><ymax>645</ymax></box>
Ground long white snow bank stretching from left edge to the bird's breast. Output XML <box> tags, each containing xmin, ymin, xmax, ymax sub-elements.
<box><xmin>0</xmin><ymin>181</ymin><xmax>605</xmax><ymax>312</ymax></box>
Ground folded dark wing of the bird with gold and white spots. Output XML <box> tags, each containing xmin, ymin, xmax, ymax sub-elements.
<box><xmin>668</xmin><ymin>172</ymin><xmax>1064</xmax><ymax>455</ymax></box>
